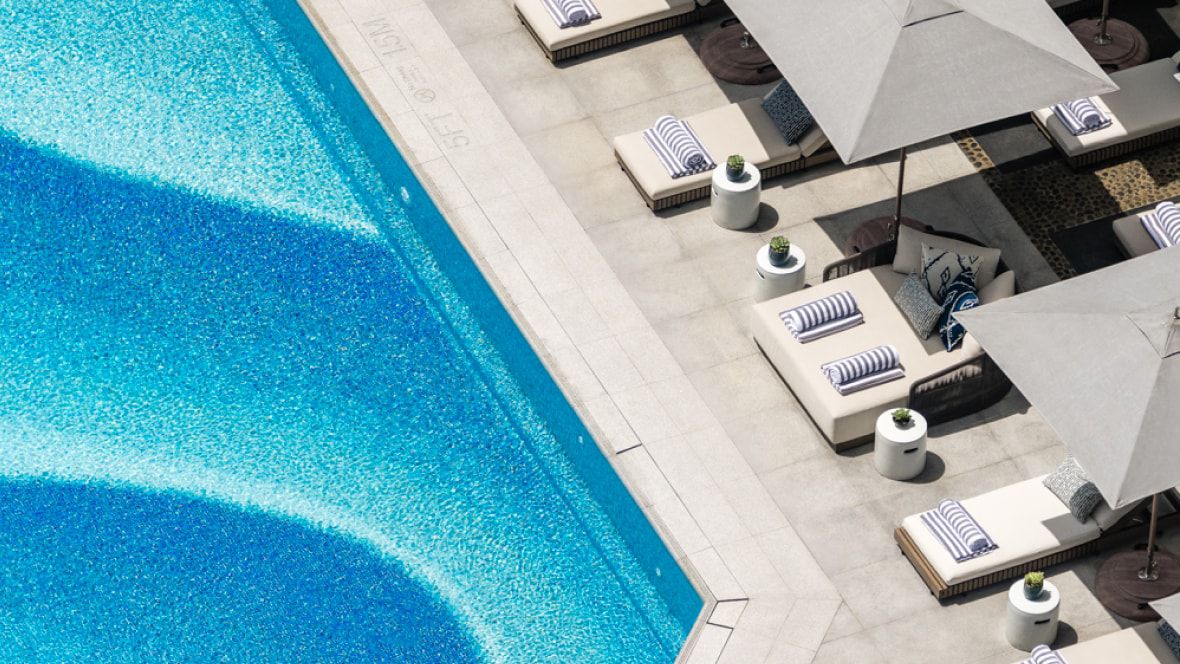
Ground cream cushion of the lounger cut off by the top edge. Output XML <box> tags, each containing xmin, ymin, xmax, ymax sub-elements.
<box><xmin>514</xmin><ymin>0</ymin><xmax>696</xmax><ymax>51</ymax></box>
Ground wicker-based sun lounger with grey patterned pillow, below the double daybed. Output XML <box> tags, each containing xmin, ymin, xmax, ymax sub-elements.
<box><xmin>893</xmin><ymin>475</ymin><xmax>1176</xmax><ymax>599</ymax></box>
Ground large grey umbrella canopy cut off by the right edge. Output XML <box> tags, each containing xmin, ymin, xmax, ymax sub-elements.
<box><xmin>956</xmin><ymin>248</ymin><xmax>1180</xmax><ymax>507</ymax></box>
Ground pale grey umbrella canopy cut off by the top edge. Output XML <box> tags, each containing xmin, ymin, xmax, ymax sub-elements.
<box><xmin>727</xmin><ymin>0</ymin><xmax>1117</xmax><ymax>164</ymax></box>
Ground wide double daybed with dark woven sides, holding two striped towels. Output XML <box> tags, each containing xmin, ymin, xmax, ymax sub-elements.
<box><xmin>750</xmin><ymin>226</ymin><xmax>1016</xmax><ymax>452</ymax></box>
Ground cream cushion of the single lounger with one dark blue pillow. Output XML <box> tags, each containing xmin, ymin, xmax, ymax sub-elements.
<box><xmin>614</xmin><ymin>98</ymin><xmax>827</xmax><ymax>200</ymax></box>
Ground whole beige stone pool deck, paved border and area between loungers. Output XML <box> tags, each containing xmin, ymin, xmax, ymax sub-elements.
<box><xmin>301</xmin><ymin>0</ymin><xmax>1165</xmax><ymax>663</ymax></box>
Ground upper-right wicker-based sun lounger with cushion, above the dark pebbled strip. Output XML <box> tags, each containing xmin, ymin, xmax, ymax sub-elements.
<box><xmin>1033</xmin><ymin>58</ymin><xmax>1180</xmax><ymax>167</ymax></box>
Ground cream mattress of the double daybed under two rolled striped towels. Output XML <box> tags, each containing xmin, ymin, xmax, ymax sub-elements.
<box><xmin>750</xmin><ymin>265</ymin><xmax>983</xmax><ymax>443</ymax></box>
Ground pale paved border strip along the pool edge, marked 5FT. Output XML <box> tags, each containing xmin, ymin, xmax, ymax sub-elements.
<box><xmin>292</xmin><ymin>0</ymin><xmax>840</xmax><ymax>662</ymax></box>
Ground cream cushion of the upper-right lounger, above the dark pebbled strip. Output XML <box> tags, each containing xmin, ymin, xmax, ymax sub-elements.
<box><xmin>1034</xmin><ymin>58</ymin><xmax>1180</xmax><ymax>157</ymax></box>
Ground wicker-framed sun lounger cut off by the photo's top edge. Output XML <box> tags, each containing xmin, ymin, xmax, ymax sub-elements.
<box><xmin>513</xmin><ymin>0</ymin><xmax>728</xmax><ymax>63</ymax></box>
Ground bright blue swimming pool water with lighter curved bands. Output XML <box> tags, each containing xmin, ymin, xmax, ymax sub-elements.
<box><xmin>0</xmin><ymin>0</ymin><xmax>701</xmax><ymax>662</ymax></box>
